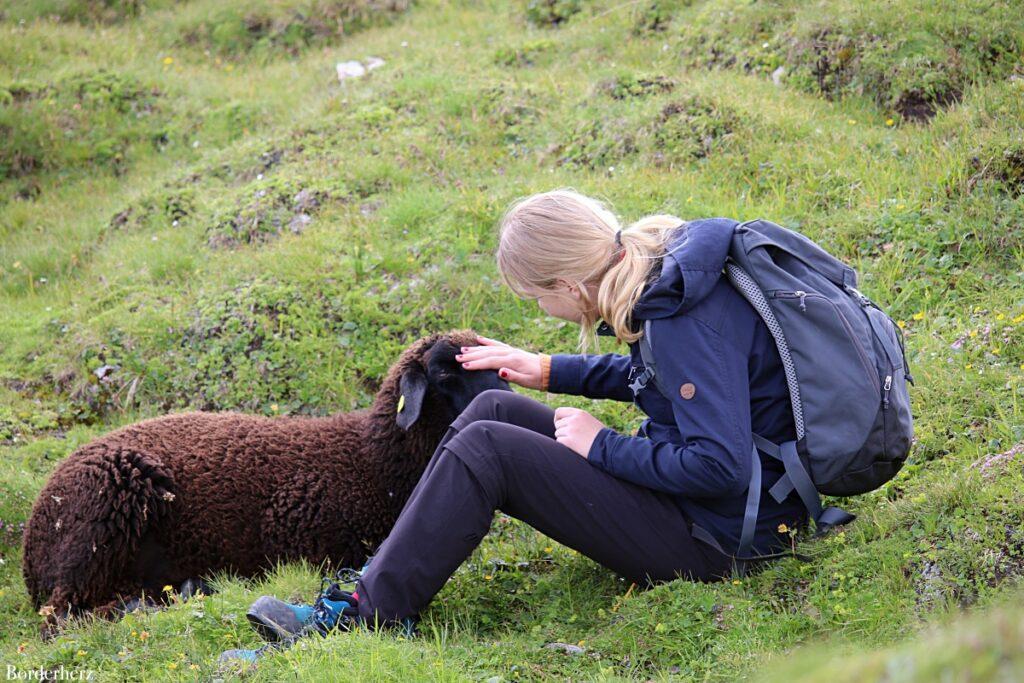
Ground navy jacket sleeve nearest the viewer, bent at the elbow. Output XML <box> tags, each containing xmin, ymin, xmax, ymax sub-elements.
<box><xmin>588</xmin><ymin>315</ymin><xmax>753</xmax><ymax>498</ymax></box>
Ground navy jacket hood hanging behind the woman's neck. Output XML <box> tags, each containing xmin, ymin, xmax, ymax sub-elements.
<box><xmin>633</xmin><ymin>218</ymin><xmax>738</xmax><ymax>319</ymax></box>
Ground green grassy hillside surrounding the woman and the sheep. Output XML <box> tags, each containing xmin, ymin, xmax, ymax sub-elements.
<box><xmin>0</xmin><ymin>0</ymin><xmax>1024</xmax><ymax>681</ymax></box>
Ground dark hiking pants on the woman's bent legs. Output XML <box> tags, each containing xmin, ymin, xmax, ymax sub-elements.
<box><xmin>356</xmin><ymin>390</ymin><xmax>731</xmax><ymax>625</ymax></box>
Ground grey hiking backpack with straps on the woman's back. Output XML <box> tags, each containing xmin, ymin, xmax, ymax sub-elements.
<box><xmin>633</xmin><ymin>219</ymin><xmax>913</xmax><ymax>560</ymax></box>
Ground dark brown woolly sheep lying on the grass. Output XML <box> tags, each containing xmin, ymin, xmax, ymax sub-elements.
<box><xmin>23</xmin><ymin>330</ymin><xmax>509</xmax><ymax>636</ymax></box>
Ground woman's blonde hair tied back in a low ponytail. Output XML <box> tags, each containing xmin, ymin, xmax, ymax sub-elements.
<box><xmin>498</xmin><ymin>187</ymin><xmax>683</xmax><ymax>351</ymax></box>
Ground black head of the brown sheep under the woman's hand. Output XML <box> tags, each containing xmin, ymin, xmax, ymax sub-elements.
<box><xmin>395</xmin><ymin>330</ymin><xmax>511</xmax><ymax>430</ymax></box>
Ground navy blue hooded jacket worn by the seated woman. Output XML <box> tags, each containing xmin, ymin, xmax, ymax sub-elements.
<box><xmin>548</xmin><ymin>218</ymin><xmax>807</xmax><ymax>553</ymax></box>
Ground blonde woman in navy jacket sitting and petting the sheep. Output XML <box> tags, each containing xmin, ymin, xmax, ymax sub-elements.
<box><xmin>222</xmin><ymin>189</ymin><xmax>806</xmax><ymax>663</ymax></box>
